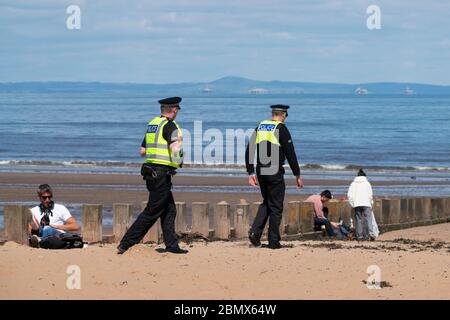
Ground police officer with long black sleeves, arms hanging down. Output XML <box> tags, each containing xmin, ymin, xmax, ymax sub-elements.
<box><xmin>245</xmin><ymin>104</ymin><xmax>303</xmax><ymax>249</ymax></box>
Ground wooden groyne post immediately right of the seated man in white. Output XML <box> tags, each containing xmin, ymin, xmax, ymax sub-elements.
<box><xmin>81</xmin><ymin>204</ymin><xmax>103</xmax><ymax>243</ymax></box>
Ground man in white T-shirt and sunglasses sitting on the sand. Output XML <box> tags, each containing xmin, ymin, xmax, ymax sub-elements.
<box><xmin>28</xmin><ymin>184</ymin><xmax>79</xmax><ymax>248</ymax></box>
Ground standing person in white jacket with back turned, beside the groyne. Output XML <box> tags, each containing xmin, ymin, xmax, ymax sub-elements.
<box><xmin>347</xmin><ymin>169</ymin><xmax>378</xmax><ymax>240</ymax></box>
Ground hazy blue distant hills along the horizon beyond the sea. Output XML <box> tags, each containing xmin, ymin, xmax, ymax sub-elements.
<box><xmin>0</xmin><ymin>77</ymin><xmax>450</xmax><ymax>95</ymax></box>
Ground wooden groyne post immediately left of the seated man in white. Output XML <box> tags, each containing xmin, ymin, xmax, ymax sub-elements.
<box><xmin>3</xmin><ymin>204</ymin><xmax>31</xmax><ymax>244</ymax></box>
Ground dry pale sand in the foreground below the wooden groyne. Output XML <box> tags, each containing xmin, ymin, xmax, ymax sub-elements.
<box><xmin>0</xmin><ymin>224</ymin><xmax>450</xmax><ymax>300</ymax></box>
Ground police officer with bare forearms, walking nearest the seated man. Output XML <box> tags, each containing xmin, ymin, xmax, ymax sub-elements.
<box><xmin>117</xmin><ymin>97</ymin><xmax>188</xmax><ymax>254</ymax></box>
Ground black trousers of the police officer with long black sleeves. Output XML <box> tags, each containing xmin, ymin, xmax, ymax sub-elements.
<box><xmin>250</xmin><ymin>171</ymin><xmax>286</xmax><ymax>245</ymax></box>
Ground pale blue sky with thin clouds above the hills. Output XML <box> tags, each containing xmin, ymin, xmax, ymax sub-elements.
<box><xmin>0</xmin><ymin>0</ymin><xmax>450</xmax><ymax>85</ymax></box>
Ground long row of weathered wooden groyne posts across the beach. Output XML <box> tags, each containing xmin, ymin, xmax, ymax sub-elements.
<box><xmin>4</xmin><ymin>198</ymin><xmax>450</xmax><ymax>244</ymax></box>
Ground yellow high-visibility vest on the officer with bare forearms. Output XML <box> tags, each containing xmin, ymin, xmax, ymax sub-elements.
<box><xmin>145</xmin><ymin>117</ymin><xmax>183</xmax><ymax>169</ymax></box>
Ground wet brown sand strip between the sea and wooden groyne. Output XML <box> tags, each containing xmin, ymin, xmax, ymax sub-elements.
<box><xmin>0</xmin><ymin>173</ymin><xmax>442</xmax><ymax>207</ymax></box>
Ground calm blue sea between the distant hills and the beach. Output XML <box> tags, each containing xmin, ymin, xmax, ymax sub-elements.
<box><xmin>0</xmin><ymin>92</ymin><xmax>450</xmax><ymax>169</ymax></box>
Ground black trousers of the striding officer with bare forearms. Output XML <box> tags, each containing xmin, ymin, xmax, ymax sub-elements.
<box><xmin>120</xmin><ymin>167</ymin><xmax>178</xmax><ymax>249</ymax></box>
